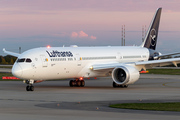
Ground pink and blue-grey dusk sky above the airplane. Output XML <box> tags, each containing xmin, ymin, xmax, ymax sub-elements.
<box><xmin>0</xmin><ymin>0</ymin><xmax>180</xmax><ymax>55</ymax></box>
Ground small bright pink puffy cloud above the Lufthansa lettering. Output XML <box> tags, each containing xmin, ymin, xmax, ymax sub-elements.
<box><xmin>71</xmin><ymin>31</ymin><xmax>97</xmax><ymax>40</ymax></box>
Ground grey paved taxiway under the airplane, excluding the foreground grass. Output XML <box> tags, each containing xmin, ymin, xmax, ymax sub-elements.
<box><xmin>0</xmin><ymin>74</ymin><xmax>180</xmax><ymax>120</ymax></box>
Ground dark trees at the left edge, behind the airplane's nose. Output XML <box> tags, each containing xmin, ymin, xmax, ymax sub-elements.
<box><xmin>0</xmin><ymin>55</ymin><xmax>17</xmax><ymax>65</ymax></box>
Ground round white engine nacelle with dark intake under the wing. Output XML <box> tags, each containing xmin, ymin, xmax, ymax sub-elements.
<box><xmin>112</xmin><ymin>65</ymin><xmax>140</xmax><ymax>85</ymax></box>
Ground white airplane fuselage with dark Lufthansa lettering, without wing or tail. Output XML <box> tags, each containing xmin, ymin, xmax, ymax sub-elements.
<box><xmin>12</xmin><ymin>46</ymin><xmax>149</xmax><ymax>80</ymax></box>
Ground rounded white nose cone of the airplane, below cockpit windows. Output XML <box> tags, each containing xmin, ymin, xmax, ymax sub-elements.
<box><xmin>12</xmin><ymin>64</ymin><xmax>23</xmax><ymax>78</ymax></box>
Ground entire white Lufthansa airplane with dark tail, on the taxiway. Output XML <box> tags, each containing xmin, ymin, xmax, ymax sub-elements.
<box><xmin>3</xmin><ymin>8</ymin><xmax>180</xmax><ymax>91</ymax></box>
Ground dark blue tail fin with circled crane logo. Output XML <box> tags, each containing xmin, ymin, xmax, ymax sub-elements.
<box><xmin>141</xmin><ymin>8</ymin><xmax>162</xmax><ymax>50</ymax></box>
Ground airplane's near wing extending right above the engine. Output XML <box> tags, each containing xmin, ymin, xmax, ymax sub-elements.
<box><xmin>90</xmin><ymin>58</ymin><xmax>180</xmax><ymax>70</ymax></box>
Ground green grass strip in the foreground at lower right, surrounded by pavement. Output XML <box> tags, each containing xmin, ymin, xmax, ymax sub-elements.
<box><xmin>109</xmin><ymin>102</ymin><xmax>180</xmax><ymax>111</ymax></box>
